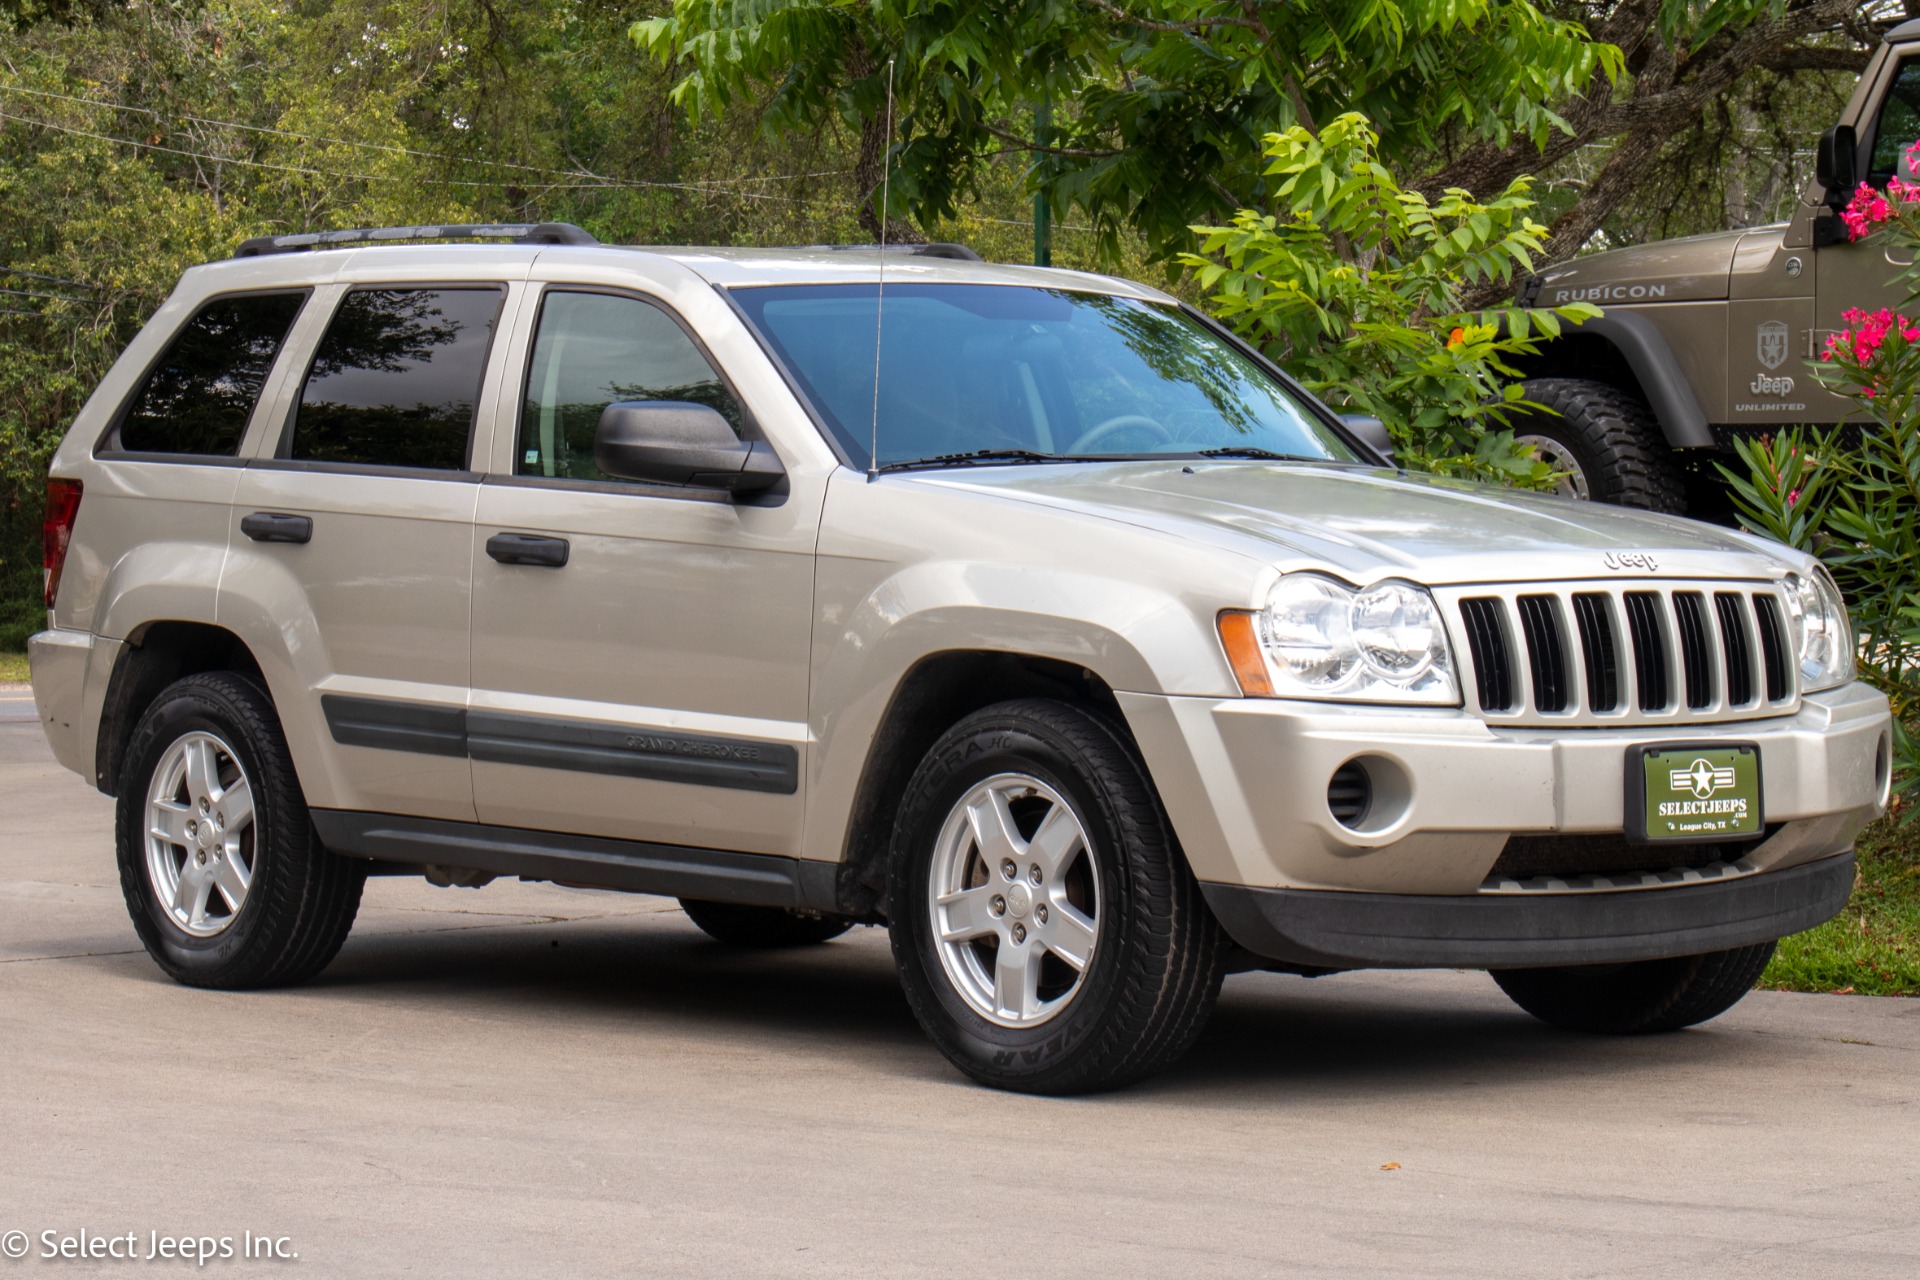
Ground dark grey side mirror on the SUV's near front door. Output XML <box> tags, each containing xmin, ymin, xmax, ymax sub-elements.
<box><xmin>593</xmin><ymin>399</ymin><xmax>787</xmax><ymax>493</ymax></box>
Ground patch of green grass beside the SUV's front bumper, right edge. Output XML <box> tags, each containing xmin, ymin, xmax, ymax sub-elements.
<box><xmin>1761</xmin><ymin>816</ymin><xmax>1920</xmax><ymax>996</ymax></box>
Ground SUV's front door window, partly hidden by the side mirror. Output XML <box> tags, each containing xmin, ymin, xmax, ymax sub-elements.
<box><xmin>515</xmin><ymin>292</ymin><xmax>741</xmax><ymax>480</ymax></box>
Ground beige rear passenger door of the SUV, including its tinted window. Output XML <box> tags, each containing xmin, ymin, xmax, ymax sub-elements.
<box><xmin>223</xmin><ymin>280</ymin><xmax>509</xmax><ymax>821</ymax></box>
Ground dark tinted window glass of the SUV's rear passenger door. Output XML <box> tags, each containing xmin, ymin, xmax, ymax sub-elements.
<box><xmin>288</xmin><ymin>288</ymin><xmax>505</xmax><ymax>470</ymax></box>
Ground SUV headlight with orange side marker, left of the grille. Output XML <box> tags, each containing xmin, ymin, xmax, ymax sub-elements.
<box><xmin>1219</xmin><ymin>574</ymin><xmax>1459</xmax><ymax>706</ymax></box>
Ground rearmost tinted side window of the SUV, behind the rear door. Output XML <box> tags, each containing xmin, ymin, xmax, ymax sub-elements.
<box><xmin>111</xmin><ymin>294</ymin><xmax>305</xmax><ymax>457</ymax></box>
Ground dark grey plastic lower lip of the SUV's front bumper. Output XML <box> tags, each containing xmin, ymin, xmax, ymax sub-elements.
<box><xmin>1200</xmin><ymin>854</ymin><xmax>1853</xmax><ymax>969</ymax></box>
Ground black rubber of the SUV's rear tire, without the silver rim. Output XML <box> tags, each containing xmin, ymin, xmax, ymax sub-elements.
<box><xmin>117</xmin><ymin>672</ymin><xmax>367</xmax><ymax>990</ymax></box>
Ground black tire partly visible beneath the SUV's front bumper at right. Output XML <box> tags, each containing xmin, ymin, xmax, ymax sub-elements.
<box><xmin>1494</xmin><ymin>942</ymin><xmax>1774</xmax><ymax>1036</ymax></box>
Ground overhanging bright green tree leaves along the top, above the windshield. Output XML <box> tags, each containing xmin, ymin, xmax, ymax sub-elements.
<box><xmin>632</xmin><ymin>0</ymin><xmax>1622</xmax><ymax>255</ymax></box>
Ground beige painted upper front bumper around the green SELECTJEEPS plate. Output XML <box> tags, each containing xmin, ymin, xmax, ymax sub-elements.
<box><xmin>1119</xmin><ymin>685</ymin><xmax>1891</xmax><ymax>894</ymax></box>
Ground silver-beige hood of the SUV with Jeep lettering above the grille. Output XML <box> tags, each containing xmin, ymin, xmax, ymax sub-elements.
<box><xmin>912</xmin><ymin>461</ymin><xmax>1807</xmax><ymax>585</ymax></box>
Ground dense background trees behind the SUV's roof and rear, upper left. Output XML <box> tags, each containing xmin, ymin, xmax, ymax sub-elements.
<box><xmin>0</xmin><ymin>0</ymin><xmax>898</xmax><ymax>649</ymax></box>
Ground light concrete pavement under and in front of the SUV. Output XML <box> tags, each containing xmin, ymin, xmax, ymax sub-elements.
<box><xmin>0</xmin><ymin>691</ymin><xmax>1920</xmax><ymax>1280</ymax></box>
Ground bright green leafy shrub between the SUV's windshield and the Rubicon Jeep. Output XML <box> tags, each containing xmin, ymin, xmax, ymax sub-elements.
<box><xmin>1179</xmin><ymin>113</ymin><xmax>1597</xmax><ymax>487</ymax></box>
